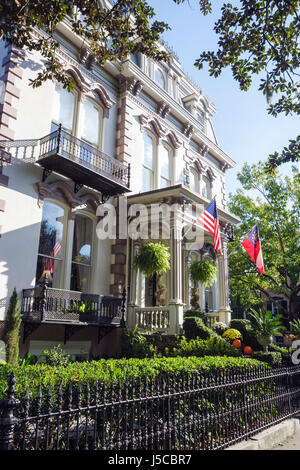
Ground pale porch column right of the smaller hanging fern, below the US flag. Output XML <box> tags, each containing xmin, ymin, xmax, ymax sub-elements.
<box><xmin>218</xmin><ymin>239</ymin><xmax>231</xmax><ymax>324</ymax></box>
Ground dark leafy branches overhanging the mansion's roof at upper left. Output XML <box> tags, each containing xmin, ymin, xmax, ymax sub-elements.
<box><xmin>0</xmin><ymin>0</ymin><xmax>169</xmax><ymax>89</ymax></box>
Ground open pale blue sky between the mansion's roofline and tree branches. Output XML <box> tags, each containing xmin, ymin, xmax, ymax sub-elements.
<box><xmin>149</xmin><ymin>0</ymin><xmax>300</xmax><ymax>193</ymax></box>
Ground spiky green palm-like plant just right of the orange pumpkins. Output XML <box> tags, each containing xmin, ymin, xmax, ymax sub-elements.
<box><xmin>249</xmin><ymin>308</ymin><xmax>285</xmax><ymax>352</ymax></box>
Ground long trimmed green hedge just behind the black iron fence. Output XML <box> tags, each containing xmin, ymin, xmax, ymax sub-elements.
<box><xmin>0</xmin><ymin>356</ymin><xmax>267</xmax><ymax>399</ymax></box>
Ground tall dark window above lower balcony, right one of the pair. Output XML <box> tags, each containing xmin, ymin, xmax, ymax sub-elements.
<box><xmin>71</xmin><ymin>214</ymin><xmax>93</xmax><ymax>292</ymax></box>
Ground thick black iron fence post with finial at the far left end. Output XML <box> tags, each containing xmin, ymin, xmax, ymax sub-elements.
<box><xmin>0</xmin><ymin>372</ymin><xmax>20</xmax><ymax>450</ymax></box>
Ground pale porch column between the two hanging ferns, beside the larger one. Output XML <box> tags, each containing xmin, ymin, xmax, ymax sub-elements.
<box><xmin>169</xmin><ymin>219</ymin><xmax>183</xmax><ymax>334</ymax></box>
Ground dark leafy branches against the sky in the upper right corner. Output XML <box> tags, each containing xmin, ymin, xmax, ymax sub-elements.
<box><xmin>191</xmin><ymin>0</ymin><xmax>300</xmax><ymax>172</ymax></box>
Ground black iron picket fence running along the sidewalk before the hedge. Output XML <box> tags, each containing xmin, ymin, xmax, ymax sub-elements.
<box><xmin>0</xmin><ymin>367</ymin><xmax>300</xmax><ymax>450</ymax></box>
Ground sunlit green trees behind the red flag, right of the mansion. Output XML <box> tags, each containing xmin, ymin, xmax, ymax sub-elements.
<box><xmin>229</xmin><ymin>163</ymin><xmax>300</xmax><ymax>317</ymax></box>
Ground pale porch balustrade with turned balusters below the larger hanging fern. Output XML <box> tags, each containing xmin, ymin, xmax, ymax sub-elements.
<box><xmin>135</xmin><ymin>307</ymin><xmax>170</xmax><ymax>330</ymax></box>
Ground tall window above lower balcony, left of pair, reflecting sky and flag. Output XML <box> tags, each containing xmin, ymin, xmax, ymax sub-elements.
<box><xmin>36</xmin><ymin>202</ymin><xmax>65</xmax><ymax>287</ymax></box>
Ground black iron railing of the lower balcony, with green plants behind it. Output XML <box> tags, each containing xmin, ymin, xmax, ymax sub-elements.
<box><xmin>21</xmin><ymin>286</ymin><xmax>126</xmax><ymax>324</ymax></box>
